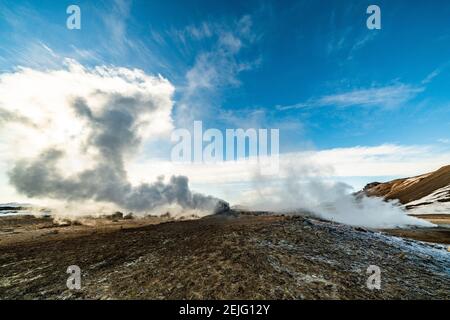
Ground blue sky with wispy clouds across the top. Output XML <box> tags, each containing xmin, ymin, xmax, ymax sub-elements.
<box><xmin>0</xmin><ymin>0</ymin><xmax>450</xmax><ymax>202</ymax></box>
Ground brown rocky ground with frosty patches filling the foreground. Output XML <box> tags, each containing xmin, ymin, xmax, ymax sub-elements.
<box><xmin>0</xmin><ymin>212</ymin><xmax>450</xmax><ymax>299</ymax></box>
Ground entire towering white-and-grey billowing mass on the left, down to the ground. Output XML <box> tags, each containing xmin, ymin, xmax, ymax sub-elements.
<box><xmin>0</xmin><ymin>61</ymin><xmax>223</xmax><ymax>212</ymax></box>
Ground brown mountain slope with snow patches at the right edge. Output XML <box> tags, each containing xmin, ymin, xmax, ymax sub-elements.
<box><xmin>362</xmin><ymin>165</ymin><xmax>450</xmax><ymax>214</ymax></box>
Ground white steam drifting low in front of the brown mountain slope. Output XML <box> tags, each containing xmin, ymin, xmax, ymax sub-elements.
<box><xmin>244</xmin><ymin>159</ymin><xmax>433</xmax><ymax>228</ymax></box>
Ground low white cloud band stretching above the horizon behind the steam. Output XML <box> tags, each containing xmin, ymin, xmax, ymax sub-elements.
<box><xmin>125</xmin><ymin>144</ymin><xmax>450</xmax><ymax>202</ymax></box>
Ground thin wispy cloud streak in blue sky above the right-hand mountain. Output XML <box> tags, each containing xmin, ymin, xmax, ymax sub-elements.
<box><xmin>277</xmin><ymin>84</ymin><xmax>425</xmax><ymax>110</ymax></box>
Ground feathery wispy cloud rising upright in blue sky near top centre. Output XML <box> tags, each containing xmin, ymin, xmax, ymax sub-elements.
<box><xmin>172</xmin><ymin>15</ymin><xmax>260</xmax><ymax>122</ymax></box>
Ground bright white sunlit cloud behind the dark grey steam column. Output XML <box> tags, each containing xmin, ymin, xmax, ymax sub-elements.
<box><xmin>0</xmin><ymin>60</ymin><xmax>174</xmax><ymax>178</ymax></box>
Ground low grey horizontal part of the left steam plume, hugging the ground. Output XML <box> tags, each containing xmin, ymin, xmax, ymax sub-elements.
<box><xmin>10</xmin><ymin>154</ymin><xmax>223</xmax><ymax>212</ymax></box>
